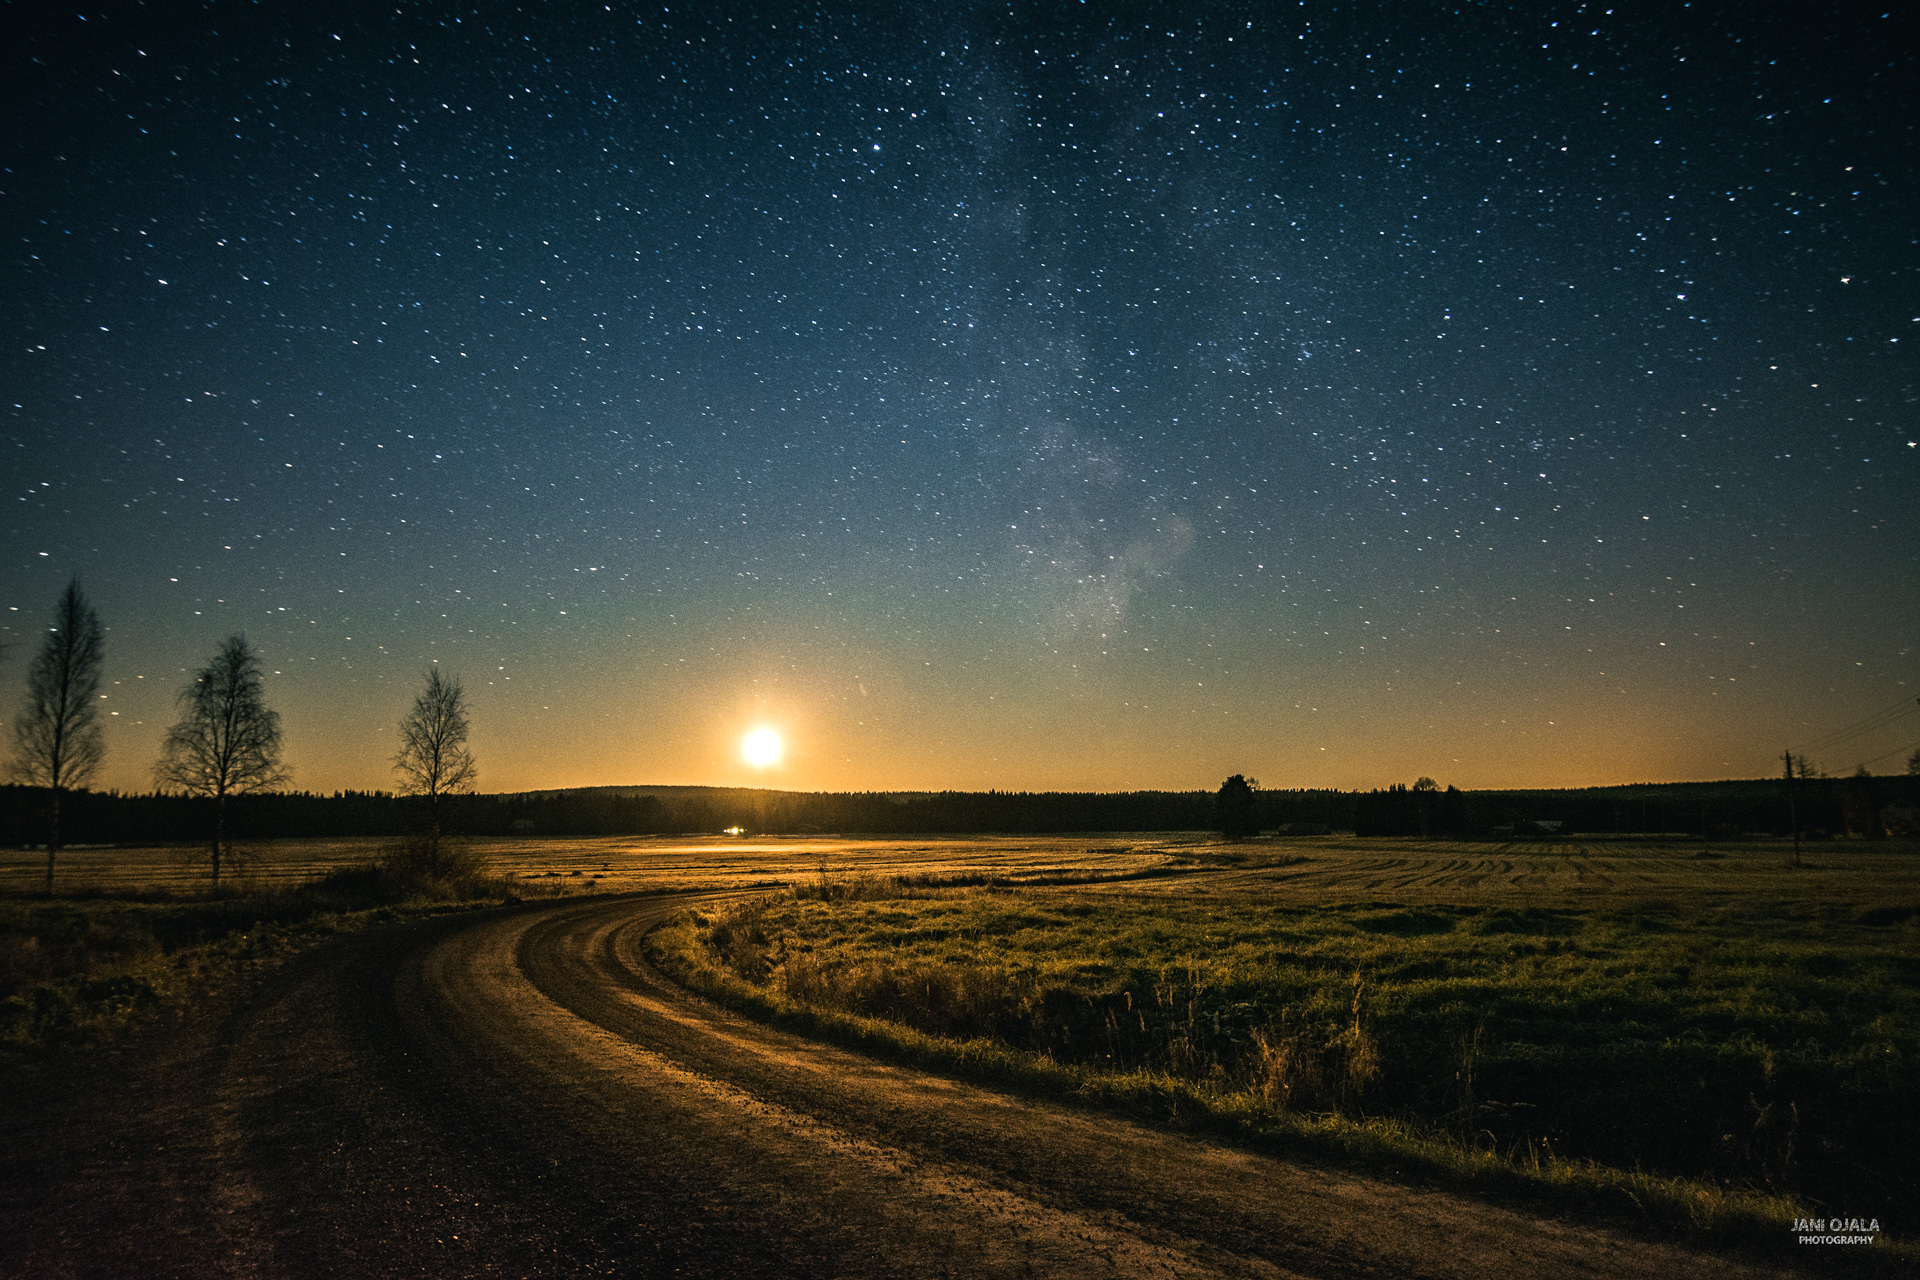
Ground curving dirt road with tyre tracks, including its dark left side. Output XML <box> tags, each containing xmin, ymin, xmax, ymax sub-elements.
<box><xmin>0</xmin><ymin>898</ymin><xmax>1797</xmax><ymax>1278</ymax></box>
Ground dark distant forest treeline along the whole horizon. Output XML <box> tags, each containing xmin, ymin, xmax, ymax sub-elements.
<box><xmin>0</xmin><ymin>777</ymin><xmax>1920</xmax><ymax>846</ymax></box>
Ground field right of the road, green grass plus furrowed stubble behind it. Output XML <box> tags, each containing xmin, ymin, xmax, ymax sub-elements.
<box><xmin>657</xmin><ymin>837</ymin><xmax>1920</xmax><ymax>1230</ymax></box>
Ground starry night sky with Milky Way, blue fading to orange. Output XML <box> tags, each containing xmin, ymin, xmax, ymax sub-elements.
<box><xmin>0</xmin><ymin>2</ymin><xmax>1920</xmax><ymax>791</ymax></box>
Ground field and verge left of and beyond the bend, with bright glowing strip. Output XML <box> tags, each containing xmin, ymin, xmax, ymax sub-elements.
<box><xmin>0</xmin><ymin>837</ymin><xmax>1190</xmax><ymax>1055</ymax></box>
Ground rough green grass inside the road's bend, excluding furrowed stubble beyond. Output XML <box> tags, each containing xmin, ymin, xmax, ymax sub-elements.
<box><xmin>649</xmin><ymin>875</ymin><xmax>1920</xmax><ymax>1270</ymax></box>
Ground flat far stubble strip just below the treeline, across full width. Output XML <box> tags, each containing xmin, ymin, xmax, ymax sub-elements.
<box><xmin>0</xmin><ymin>833</ymin><xmax>1920</xmax><ymax>912</ymax></box>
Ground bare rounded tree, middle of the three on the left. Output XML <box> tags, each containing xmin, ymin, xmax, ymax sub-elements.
<box><xmin>154</xmin><ymin>635</ymin><xmax>286</xmax><ymax>892</ymax></box>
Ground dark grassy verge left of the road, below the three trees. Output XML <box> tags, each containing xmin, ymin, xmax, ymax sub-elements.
<box><xmin>0</xmin><ymin>846</ymin><xmax>551</xmax><ymax>1061</ymax></box>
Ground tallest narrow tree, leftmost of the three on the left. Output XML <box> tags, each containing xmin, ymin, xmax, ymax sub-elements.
<box><xmin>10</xmin><ymin>578</ymin><xmax>108</xmax><ymax>898</ymax></box>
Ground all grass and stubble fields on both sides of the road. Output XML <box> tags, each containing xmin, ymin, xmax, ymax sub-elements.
<box><xmin>15</xmin><ymin>833</ymin><xmax>1920</xmax><ymax>1232</ymax></box>
